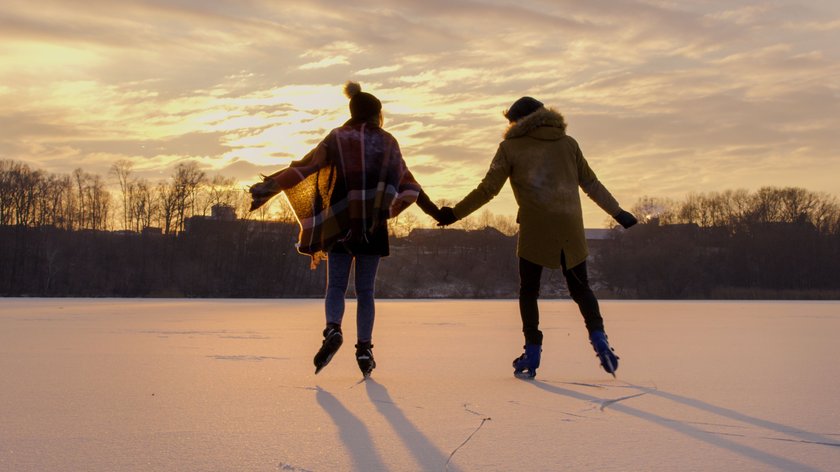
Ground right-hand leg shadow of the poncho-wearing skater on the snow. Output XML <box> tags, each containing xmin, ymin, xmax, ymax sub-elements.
<box><xmin>365</xmin><ymin>378</ymin><xmax>458</xmax><ymax>470</ymax></box>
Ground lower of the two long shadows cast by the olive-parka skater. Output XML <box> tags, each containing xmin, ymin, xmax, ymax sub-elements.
<box><xmin>529</xmin><ymin>380</ymin><xmax>819</xmax><ymax>472</ymax></box>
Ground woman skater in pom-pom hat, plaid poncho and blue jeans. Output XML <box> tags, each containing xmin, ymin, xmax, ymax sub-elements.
<box><xmin>249</xmin><ymin>82</ymin><xmax>439</xmax><ymax>377</ymax></box>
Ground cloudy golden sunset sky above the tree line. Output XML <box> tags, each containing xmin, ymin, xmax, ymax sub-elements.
<box><xmin>0</xmin><ymin>0</ymin><xmax>840</xmax><ymax>227</ymax></box>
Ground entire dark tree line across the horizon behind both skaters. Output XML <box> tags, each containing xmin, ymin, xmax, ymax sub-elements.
<box><xmin>0</xmin><ymin>161</ymin><xmax>840</xmax><ymax>299</ymax></box>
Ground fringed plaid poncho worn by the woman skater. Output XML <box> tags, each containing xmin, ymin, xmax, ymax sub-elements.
<box><xmin>251</xmin><ymin>123</ymin><xmax>421</xmax><ymax>268</ymax></box>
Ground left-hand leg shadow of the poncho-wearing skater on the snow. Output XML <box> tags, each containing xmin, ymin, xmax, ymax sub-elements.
<box><xmin>315</xmin><ymin>387</ymin><xmax>387</xmax><ymax>470</ymax></box>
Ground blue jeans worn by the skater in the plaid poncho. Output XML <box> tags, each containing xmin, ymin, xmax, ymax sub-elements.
<box><xmin>325</xmin><ymin>252</ymin><xmax>380</xmax><ymax>342</ymax></box>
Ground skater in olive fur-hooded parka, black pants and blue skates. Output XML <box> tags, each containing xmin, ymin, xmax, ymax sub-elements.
<box><xmin>438</xmin><ymin>97</ymin><xmax>637</xmax><ymax>378</ymax></box>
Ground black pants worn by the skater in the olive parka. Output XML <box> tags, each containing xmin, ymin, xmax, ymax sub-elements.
<box><xmin>519</xmin><ymin>257</ymin><xmax>604</xmax><ymax>345</ymax></box>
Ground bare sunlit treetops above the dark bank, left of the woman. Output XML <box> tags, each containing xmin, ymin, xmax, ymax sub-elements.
<box><xmin>0</xmin><ymin>160</ymin><xmax>253</xmax><ymax>234</ymax></box>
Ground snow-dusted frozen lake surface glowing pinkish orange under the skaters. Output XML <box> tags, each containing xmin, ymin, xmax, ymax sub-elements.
<box><xmin>0</xmin><ymin>299</ymin><xmax>840</xmax><ymax>472</ymax></box>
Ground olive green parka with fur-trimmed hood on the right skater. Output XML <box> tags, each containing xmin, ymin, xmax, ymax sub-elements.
<box><xmin>453</xmin><ymin>108</ymin><xmax>621</xmax><ymax>269</ymax></box>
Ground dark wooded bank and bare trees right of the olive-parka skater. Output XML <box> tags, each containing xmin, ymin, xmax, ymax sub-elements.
<box><xmin>596</xmin><ymin>187</ymin><xmax>840</xmax><ymax>299</ymax></box>
